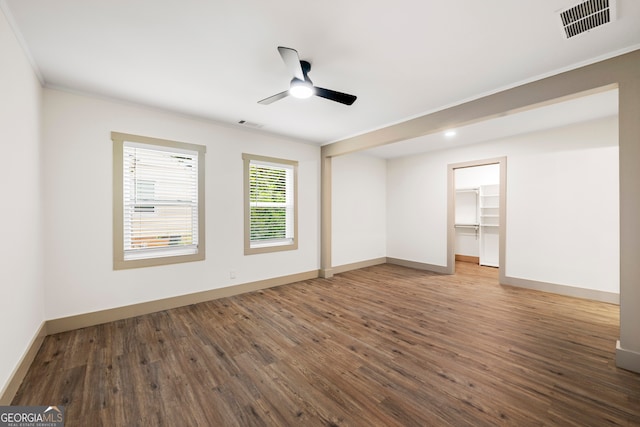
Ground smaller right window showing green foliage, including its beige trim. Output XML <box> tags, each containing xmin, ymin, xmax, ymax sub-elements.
<box><xmin>242</xmin><ymin>154</ymin><xmax>298</xmax><ymax>255</ymax></box>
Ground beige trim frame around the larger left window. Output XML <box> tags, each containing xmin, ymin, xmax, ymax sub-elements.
<box><xmin>111</xmin><ymin>132</ymin><xmax>206</xmax><ymax>270</ymax></box>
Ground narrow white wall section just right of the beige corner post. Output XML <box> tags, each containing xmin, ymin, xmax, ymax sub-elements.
<box><xmin>331</xmin><ymin>154</ymin><xmax>387</xmax><ymax>267</ymax></box>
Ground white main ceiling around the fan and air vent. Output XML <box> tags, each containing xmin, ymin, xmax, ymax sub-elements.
<box><xmin>0</xmin><ymin>0</ymin><xmax>640</xmax><ymax>150</ymax></box>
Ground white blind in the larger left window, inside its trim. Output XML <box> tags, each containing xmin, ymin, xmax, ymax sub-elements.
<box><xmin>123</xmin><ymin>141</ymin><xmax>198</xmax><ymax>260</ymax></box>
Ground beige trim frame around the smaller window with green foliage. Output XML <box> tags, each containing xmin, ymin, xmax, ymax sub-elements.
<box><xmin>242</xmin><ymin>153</ymin><xmax>298</xmax><ymax>255</ymax></box>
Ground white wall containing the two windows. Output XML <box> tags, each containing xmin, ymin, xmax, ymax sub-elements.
<box><xmin>44</xmin><ymin>89</ymin><xmax>320</xmax><ymax>319</ymax></box>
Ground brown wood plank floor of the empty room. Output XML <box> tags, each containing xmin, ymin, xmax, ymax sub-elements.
<box><xmin>13</xmin><ymin>263</ymin><xmax>640</xmax><ymax>427</ymax></box>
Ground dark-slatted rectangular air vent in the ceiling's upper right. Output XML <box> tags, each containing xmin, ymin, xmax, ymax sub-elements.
<box><xmin>560</xmin><ymin>0</ymin><xmax>616</xmax><ymax>39</ymax></box>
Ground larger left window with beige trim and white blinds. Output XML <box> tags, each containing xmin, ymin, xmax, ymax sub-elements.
<box><xmin>111</xmin><ymin>132</ymin><xmax>206</xmax><ymax>269</ymax></box>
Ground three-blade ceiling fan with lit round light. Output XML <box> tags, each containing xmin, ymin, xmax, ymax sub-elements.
<box><xmin>258</xmin><ymin>46</ymin><xmax>357</xmax><ymax>105</ymax></box>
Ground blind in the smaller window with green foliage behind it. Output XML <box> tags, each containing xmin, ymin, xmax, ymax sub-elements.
<box><xmin>249</xmin><ymin>160</ymin><xmax>294</xmax><ymax>247</ymax></box>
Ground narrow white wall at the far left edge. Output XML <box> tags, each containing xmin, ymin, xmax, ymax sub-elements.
<box><xmin>0</xmin><ymin>11</ymin><xmax>44</xmax><ymax>390</ymax></box>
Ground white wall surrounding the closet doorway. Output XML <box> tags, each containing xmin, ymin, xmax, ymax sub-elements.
<box><xmin>387</xmin><ymin>117</ymin><xmax>620</xmax><ymax>293</ymax></box>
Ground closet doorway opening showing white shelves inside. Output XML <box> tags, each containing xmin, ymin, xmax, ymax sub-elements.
<box><xmin>448</xmin><ymin>158</ymin><xmax>506</xmax><ymax>276</ymax></box>
